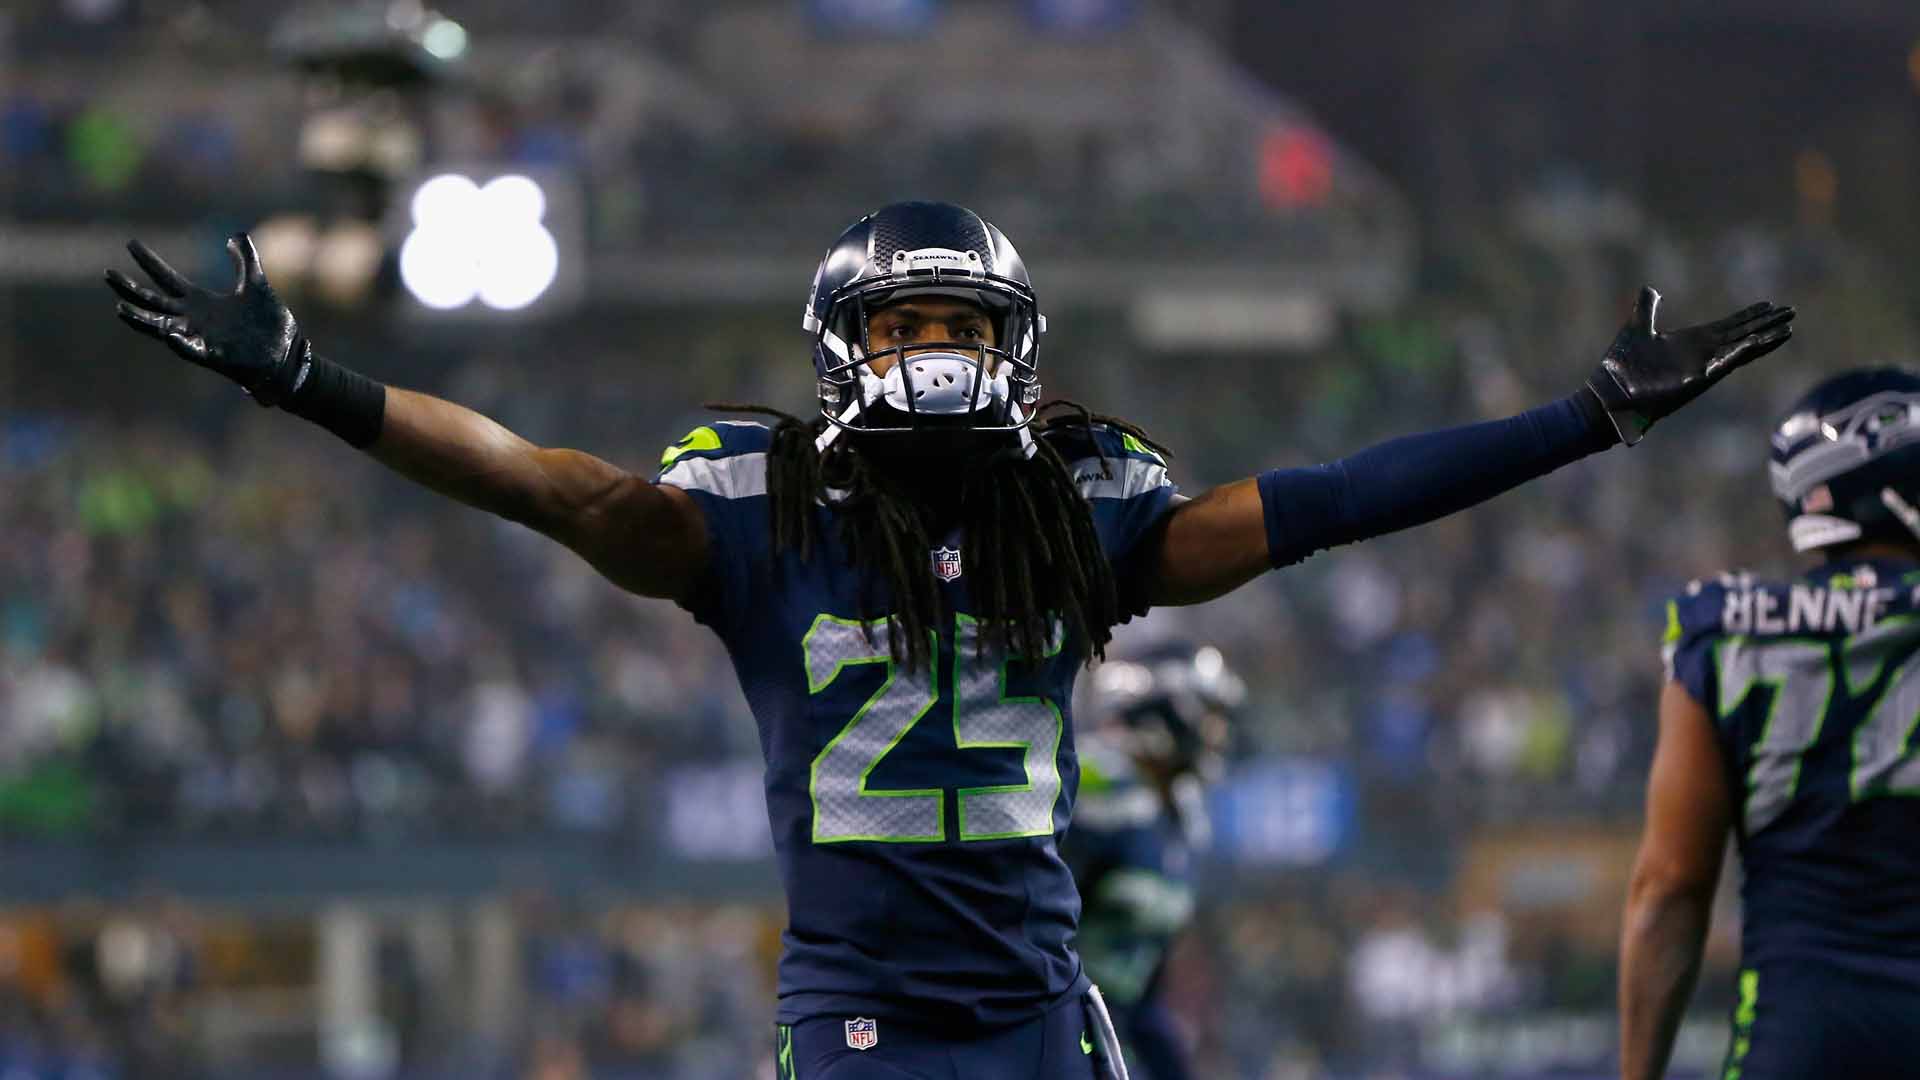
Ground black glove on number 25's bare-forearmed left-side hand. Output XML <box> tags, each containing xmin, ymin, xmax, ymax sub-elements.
<box><xmin>108</xmin><ymin>233</ymin><xmax>313</xmax><ymax>405</ymax></box>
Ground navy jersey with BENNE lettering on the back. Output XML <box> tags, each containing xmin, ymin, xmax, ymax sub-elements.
<box><xmin>1667</xmin><ymin>563</ymin><xmax>1920</xmax><ymax>980</ymax></box>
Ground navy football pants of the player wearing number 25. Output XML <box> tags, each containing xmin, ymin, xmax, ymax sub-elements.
<box><xmin>774</xmin><ymin>995</ymin><xmax>1100</xmax><ymax>1080</ymax></box>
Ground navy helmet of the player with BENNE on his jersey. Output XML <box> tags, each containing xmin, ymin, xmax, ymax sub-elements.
<box><xmin>1770</xmin><ymin>367</ymin><xmax>1920</xmax><ymax>552</ymax></box>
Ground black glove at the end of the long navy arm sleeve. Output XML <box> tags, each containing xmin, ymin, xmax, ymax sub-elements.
<box><xmin>1586</xmin><ymin>284</ymin><xmax>1793</xmax><ymax>446</ymax></box>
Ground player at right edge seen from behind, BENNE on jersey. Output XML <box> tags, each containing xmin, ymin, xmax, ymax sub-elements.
<box><xmin>1620</xmin><ymin>369</ymin><xmax>1920</xmax><ymax>1080</ymax></box>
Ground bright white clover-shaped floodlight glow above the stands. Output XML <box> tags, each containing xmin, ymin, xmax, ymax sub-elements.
<box><xmin>399</xmin><ymin>173</ymin><xmax>561</xmax><ymax>311</ymax></box>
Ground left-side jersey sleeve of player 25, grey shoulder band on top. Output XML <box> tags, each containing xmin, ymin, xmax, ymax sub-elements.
<box><xmin>655</xmin><ymin>421</ymin><xmax>772</xmax><ymax>636</ymax></box>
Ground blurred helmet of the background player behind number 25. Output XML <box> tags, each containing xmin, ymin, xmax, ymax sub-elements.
<box><xmin>1085</xmin><ymin>642</ymin><xmax>1246</xmax><ymax>780</ymax></box>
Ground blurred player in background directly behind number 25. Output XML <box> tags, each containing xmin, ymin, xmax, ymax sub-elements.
<box><xmin>1064</xmin><ymin>642</ymin><xmax>1246</xmax><ymax>1080</ymax></box>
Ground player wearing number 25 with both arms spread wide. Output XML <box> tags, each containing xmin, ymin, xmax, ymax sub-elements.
<box><xmin>108</xmin><ymin>202</ymin><xmax>1793</xmax><ymax>1080</ymax></box>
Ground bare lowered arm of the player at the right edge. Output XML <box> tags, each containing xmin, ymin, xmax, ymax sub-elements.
<box><xmin>1620</xmin><ymin>682</ymin><xmax>1734</xmax><ymax>1080</ymax></box>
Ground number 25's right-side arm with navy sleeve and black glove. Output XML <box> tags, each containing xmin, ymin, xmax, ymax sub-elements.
<box><xmin>1150</xmin><ymin>288</ymin><xmax>1793</xmax><ymax>603</ymax></box>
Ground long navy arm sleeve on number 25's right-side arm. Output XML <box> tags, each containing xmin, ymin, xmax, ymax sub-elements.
<box><xmin>1260</xmin><ymin>388</ymin><xmax>1619</xmax><ymax>567</ymax></box>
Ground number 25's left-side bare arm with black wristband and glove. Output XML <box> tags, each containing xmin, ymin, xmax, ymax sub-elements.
<box><xmin>108</xmin><ymin>234</ymin><xmax>708</xmax><ymax>600</ymax></box>
